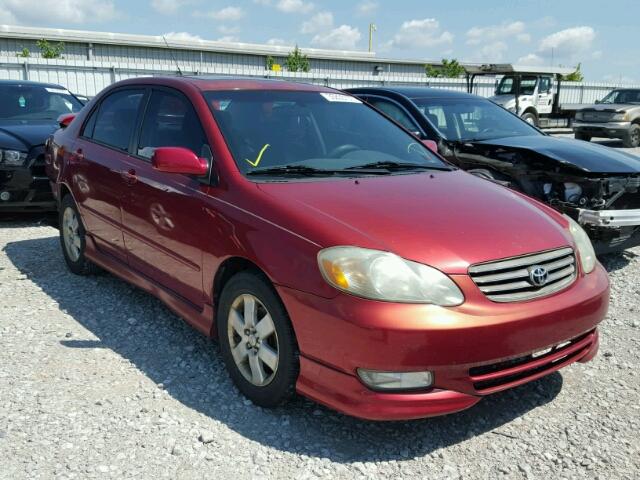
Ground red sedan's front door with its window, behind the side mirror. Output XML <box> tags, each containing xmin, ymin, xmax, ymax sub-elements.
<box><xmin>123</xmin><ymin>88</ymin><xmax>212</xmax><ymax>306</ymax></box>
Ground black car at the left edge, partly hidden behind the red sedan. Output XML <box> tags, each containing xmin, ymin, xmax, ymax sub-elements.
<box><xmin>0</xmin><ymin>80</ymin><xmax>82</xmax><ymax>213</ymax></box>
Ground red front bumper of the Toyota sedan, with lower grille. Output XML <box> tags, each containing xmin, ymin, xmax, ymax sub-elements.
<box><xmin>278</xmin><ymin>266</ymin><xmax>609</xmax><ymax>420</ymax></box>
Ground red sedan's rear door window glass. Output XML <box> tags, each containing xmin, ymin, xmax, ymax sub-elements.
<box><xmin>89</xmin><ymin>90</ymin><xmax>144</xmax><ymax>150</ymax></box>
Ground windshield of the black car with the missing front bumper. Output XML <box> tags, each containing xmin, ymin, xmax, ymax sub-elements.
<box><xmin>412</xmin><ymin>98</ymin><xmax>541</xmax><ymax>142</ymax></box>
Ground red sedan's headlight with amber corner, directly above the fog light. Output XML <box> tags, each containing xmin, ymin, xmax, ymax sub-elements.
<box><xmin>318</xmin><ymin>247</ymin><xmax>464</xmax><ymax>307</ymax></box>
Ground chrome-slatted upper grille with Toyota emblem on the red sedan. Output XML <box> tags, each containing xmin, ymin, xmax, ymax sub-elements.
<box><xmin>469</xmin><ymin>247</ymin><xmax>576</xmax><ymax>302</ymax></box>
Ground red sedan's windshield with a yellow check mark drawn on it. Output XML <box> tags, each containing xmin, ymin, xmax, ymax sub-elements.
<box><xmin>204</xmin><ymin>90</ymin><xmax>450</xmax><ymax>175</ymax></box>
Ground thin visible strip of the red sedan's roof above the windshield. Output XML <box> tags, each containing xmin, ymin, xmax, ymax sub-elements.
<box><xmin>118</xmin><ymin>75</ymin><xmax>336</xmax><ymax>92</ymax></box>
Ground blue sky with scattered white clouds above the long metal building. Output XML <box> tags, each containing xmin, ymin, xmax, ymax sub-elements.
<box><xmin>0</xmin><ymin>0</ymin><xmax>640</xmax><ymax>82</ymax></box>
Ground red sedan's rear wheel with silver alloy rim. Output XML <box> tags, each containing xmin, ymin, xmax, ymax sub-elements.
<box><xmin>58</xmin><ymin>195</ymin><xmax>100</xmax><ymax>275</ymax></box>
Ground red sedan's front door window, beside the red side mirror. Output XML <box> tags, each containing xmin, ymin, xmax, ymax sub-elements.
<box><xmin>137</xmin><ymin>91</ymin><xmax>207</xmax><ymax>158</ymax></box>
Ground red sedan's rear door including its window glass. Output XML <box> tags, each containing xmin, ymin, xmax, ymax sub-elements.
<box><xmin>70</xmin><ymin>88</ymin><xmax>145</xmax><ymax>261</ymax></box>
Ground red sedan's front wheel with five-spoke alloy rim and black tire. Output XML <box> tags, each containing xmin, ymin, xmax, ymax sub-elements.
<box><xmin>216</xmin><ymin>272</ymin><xmax>300</xmax><ymax>407</ymax></box>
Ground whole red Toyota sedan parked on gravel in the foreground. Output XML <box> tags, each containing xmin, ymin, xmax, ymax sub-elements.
<box><xmin>47</xmin><ymin>77</ymin><xmax>609</xmax><ymax>420</ymax></box>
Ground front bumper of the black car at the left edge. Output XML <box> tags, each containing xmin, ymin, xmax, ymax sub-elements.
<box><xmin>0</xmin><ymin>167</ymin><xmax>56</xmax><ymax>212</ymax></box>
